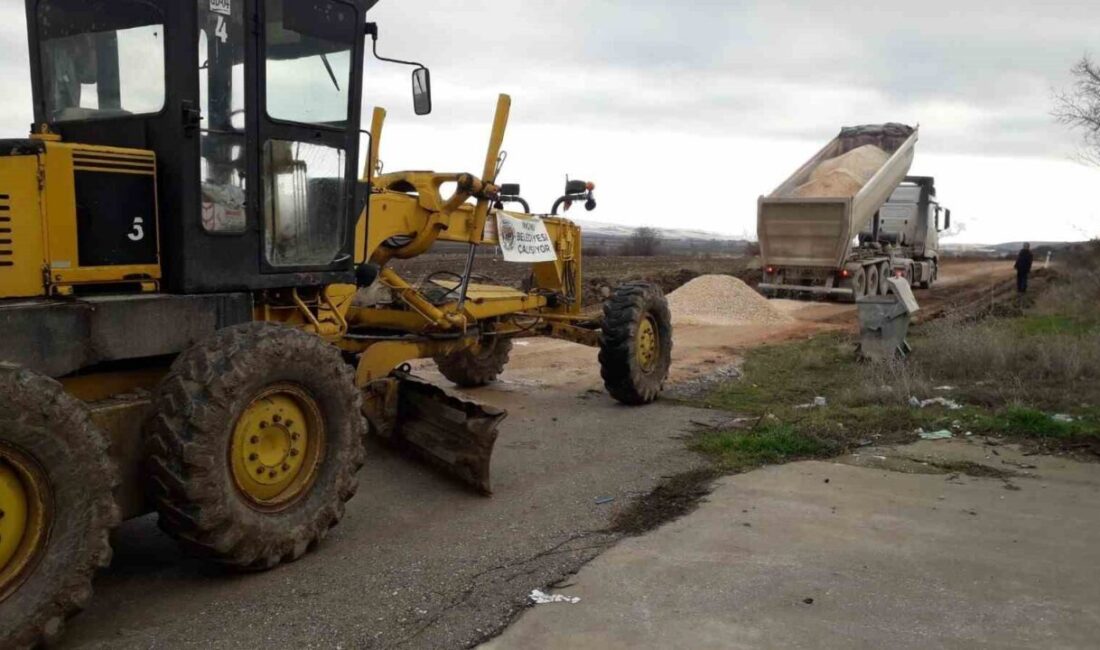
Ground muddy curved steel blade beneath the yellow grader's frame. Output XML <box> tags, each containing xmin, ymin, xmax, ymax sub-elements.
<box><xmin>364</xmin><ymin>373</ymin><xmax>508</xmax><ymax>495</ymax></box>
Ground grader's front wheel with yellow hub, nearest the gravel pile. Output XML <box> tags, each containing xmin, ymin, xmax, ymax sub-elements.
<box><xmin>600</xmin><ymin>283</ymin><xmax>672</xmax><ymax>406</ymax></box>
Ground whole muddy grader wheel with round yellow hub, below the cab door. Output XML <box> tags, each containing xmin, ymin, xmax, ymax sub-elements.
<box><xmin>147</xmin><ymin>323</ymin><xmax>366</xmax><ymax>571</ymax></box>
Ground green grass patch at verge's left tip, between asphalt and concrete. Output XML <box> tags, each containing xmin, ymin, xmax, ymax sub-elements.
<box><xmin>692</xmin><ymin>422</ymin><xmax>838</xmax><ymax>472</ymax></box>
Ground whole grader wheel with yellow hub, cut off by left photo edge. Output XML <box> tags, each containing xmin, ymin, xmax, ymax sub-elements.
<box><xmin>0</xmin><ymin>364</ymin><xmax>119</xmax><ymax>648</ymax></box>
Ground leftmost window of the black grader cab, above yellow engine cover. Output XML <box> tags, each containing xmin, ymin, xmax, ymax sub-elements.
<box><xmin>36</xmin><ymin>0</ymin><xmax>165</xmax><ymax>122</ymax></box>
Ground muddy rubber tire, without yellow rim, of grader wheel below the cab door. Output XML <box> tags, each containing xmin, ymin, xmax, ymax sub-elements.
<box><xmin>146</xmin><ymin>322</ymin><xmax>366</xmax><ymax>571</ymax></box>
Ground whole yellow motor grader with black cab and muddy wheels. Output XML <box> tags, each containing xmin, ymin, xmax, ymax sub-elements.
<box><xmin>0</xmin><ymin>0</ymin><xmax>671</xmax><ymax>648</ymax></box>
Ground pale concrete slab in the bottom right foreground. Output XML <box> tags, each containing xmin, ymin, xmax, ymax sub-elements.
<box><xmin>484</xmin><ymin>441</ymin><xmax>1100</xmax><ymax>650</ymax></box>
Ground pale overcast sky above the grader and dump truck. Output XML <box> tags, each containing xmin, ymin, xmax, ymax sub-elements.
<box><xmin>0</xmin><ymin>0</ymin><xmax>1100</xmax><ymax>242</ymax></box>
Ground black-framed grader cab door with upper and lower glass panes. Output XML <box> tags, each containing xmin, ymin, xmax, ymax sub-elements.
<box><xmin>253</xmin><ymin>0</ymin><xmax>364</xmax><ymax>274</ymax></box>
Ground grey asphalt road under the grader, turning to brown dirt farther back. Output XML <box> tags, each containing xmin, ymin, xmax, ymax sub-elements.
<box><xmin>55</xmin><ymin>258</ymin><xmax>1001</xmax><ymax>648</ymax></box>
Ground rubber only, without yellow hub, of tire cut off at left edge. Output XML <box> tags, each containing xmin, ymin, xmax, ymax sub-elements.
<box><xmin>0</xmin><ymin>363</ymin><xmax>120</xmax><ymax>648</ymax></box>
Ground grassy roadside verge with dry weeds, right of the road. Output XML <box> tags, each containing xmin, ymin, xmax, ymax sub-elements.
<box><xmin>690</xmin><ymin>247</ymin><xmax>1100</xmax><ymax>472</ymax></box>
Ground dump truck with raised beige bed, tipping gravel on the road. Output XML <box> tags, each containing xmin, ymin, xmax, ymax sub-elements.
<box><xmin>757</xmin><ymin>123</ymin><xmax>950</xmax><ymax>301</ymax></box>
